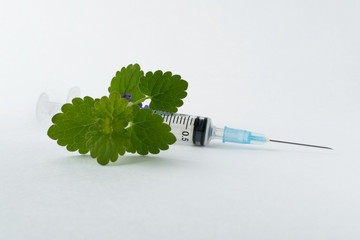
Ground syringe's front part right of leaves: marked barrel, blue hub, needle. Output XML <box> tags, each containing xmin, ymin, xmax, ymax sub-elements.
<box><xmin>154</xmin><ymin>110</ymin><xmax>332</xmax><ymax>150</ymax></box>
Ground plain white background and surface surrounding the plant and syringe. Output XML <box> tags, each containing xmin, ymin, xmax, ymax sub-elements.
<box><xmin>0</xmin><ymin>0</ymin><xmax>360</xmax><ymax>240</ymax></box>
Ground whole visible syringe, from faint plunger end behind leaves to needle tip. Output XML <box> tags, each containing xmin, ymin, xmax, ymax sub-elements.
<box><xmin>36</xmin><ymin>87</ymin><xmax>332</xmax><ymax>150</ymax></box>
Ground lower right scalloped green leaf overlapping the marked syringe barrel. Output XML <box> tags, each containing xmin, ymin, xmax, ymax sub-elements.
<box><xmin>126</xmin><ymin>105</ymin><xmax>176</xmax><ymax>155</ymax></box>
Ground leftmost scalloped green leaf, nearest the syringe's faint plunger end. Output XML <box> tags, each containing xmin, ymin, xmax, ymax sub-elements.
<box><xmin>48</xmin><ymin>97</ymin><xmax>98</xmax><ymax>154</ymax></box>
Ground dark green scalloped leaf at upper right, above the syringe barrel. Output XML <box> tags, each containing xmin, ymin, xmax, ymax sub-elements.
<box><xmin>139</xmin><ymin>70</ymin><xmax>188</xmax><ymax>112</ymax></box>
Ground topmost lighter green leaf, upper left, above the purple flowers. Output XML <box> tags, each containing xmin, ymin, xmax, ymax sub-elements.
<box><xmin>109</xmin><ymin>64</ymin><xmax>145</xmax><ymax>102</ymax></box>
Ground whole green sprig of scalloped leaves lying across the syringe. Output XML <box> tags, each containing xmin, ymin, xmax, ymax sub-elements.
<box><xmin>48</xmin><ymin>64</ymin><xmax>188</xmax><ymax>165</ymax></box>
